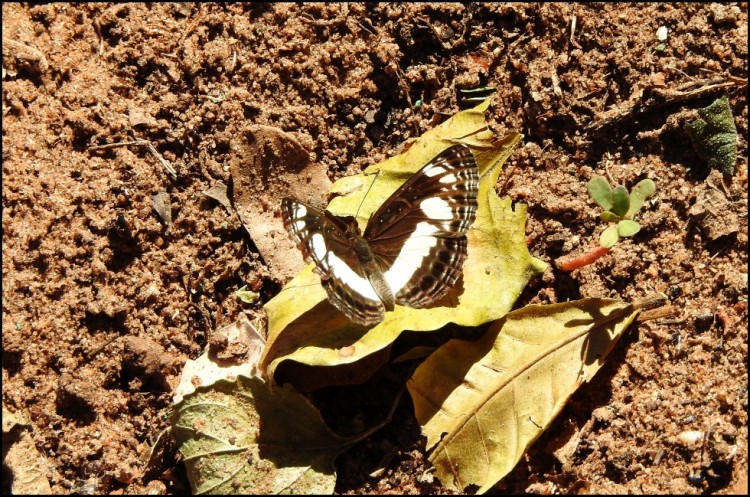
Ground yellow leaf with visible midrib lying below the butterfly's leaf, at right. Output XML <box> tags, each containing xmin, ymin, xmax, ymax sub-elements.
<box><xmin>407</xmin><ymin>299</ymin><xmax>637</xmax><ymax>493</ymax></box>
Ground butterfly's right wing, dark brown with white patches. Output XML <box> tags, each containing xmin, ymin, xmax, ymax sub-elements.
<box><xmin>365</xmin><ymin>144</ymin><xmax>479</xmax><ymax>308</ymax></box>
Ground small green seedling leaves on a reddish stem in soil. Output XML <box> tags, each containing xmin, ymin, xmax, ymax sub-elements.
<box><xmin>586</xmin><ymin>176</ymin><xmax>656</xmax><ymax>248</ymax></box>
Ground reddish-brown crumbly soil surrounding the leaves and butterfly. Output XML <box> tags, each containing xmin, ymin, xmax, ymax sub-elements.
<box><xmin>2</xmin><ymin>3</ymin><xmax>748</xmax><ymax>493</ymax></box>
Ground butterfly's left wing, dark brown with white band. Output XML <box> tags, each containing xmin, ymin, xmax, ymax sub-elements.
<box><xmin>281</xmin><ymin>198</ymin><xmax>385</xmax><ymax>326</ymax></box>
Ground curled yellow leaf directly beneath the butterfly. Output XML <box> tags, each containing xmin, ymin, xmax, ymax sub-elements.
<box><xmin>261</xmin><ymin>100</ymin><xmax>545</xmax><ymax>386</ymax></box>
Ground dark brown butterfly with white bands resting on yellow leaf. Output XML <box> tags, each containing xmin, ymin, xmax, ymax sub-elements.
<box><xmin>281</xmin><ymin>144</ymin><xmax>479</xmax><ymax>326</ymax></box>
